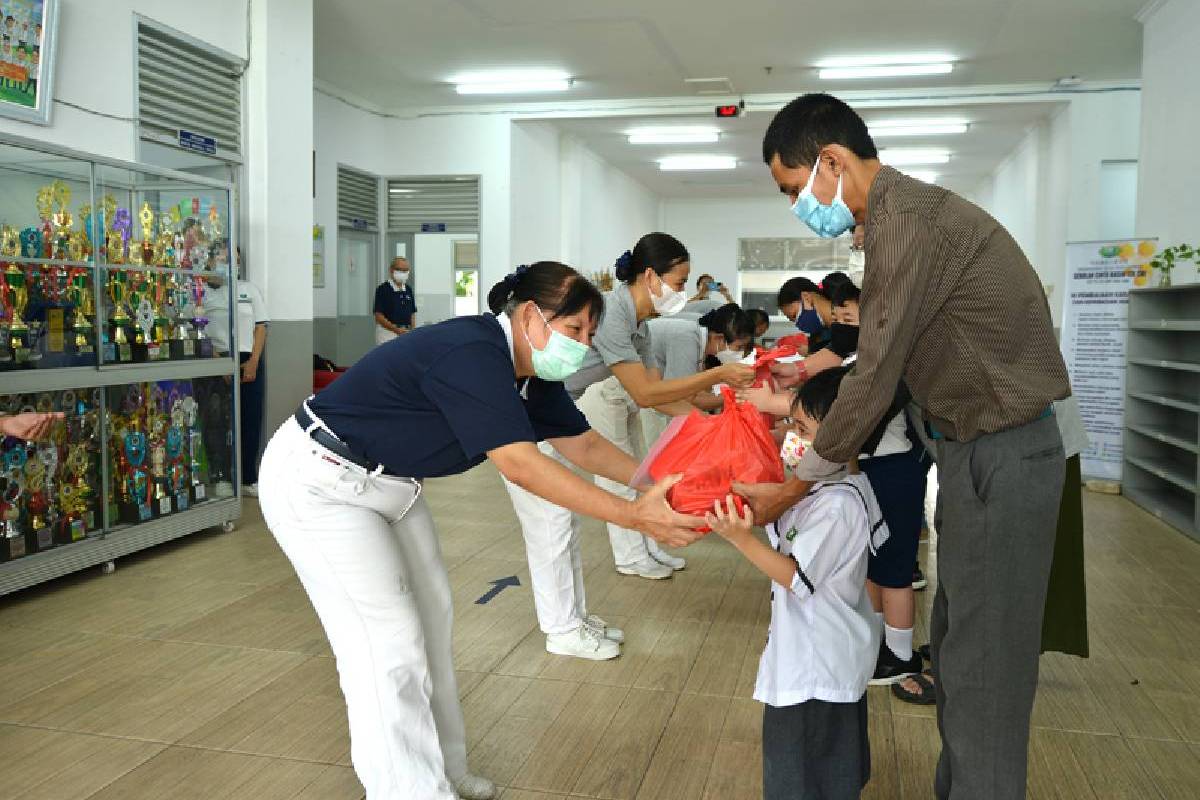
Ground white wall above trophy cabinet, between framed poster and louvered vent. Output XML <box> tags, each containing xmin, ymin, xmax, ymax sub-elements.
<box><xmin>0</xmin><ymin>0</ymin><xmax>247</xmax><ymax>160</ymax></box>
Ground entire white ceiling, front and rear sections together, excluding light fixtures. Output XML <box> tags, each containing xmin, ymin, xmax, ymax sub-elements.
<box><xmin>314</xmin><ymin>0</ymin><xmax>1146</xmax><ymax>197</ymax></box>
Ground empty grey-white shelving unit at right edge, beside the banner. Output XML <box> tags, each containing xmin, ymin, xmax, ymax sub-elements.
<box><xmin>1122</xmin><ymin>284</ymin><xmax>1200</xmax><ymax>539</ymax></box>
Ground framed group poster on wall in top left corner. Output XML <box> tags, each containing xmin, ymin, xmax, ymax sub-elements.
<box><xmin>0</xmin><ymin>0</ymin><xmax>59</xmax><ymax>125</ymax></box>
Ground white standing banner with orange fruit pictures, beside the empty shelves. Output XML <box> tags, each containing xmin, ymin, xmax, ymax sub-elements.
<box><xmin>1062</xmin><ymin>239</ymin><xmax>1158</xmax><ymax>481</ymax></box>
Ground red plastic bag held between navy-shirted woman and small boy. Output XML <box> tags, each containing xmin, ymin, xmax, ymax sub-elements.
<box><xmin>634</xmin><ymin>389</ymin><xmax>784</xmax><ymax>530</ymax></box>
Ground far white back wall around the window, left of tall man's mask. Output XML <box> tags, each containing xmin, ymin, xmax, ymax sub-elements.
<box><xmin>662</xmin><ymin>196</ymin><xmax>814</xmax><ymax>297</ymax></box>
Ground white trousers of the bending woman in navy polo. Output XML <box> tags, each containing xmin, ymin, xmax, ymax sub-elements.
<box><xmin>258</xmin><ymin>420</ymin><xmax>467</xmax><ymax>800</ymax></box>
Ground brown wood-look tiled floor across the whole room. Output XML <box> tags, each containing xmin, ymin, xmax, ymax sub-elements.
<box><xmin>0</xmin><ymin>467</ymin><xmax>1200</xmax><ymax>800</ymax></box>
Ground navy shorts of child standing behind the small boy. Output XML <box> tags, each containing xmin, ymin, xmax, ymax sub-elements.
<box><xmin>859</xmin><ymin>446</ymin><xmax>929</xmax><ymax>589</ymax></box>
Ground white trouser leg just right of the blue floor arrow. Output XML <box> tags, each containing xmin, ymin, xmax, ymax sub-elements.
<box><xmin>504</xmin><ymin>441</ymin><xmax>587</xmax><ymax>633</ymax></box>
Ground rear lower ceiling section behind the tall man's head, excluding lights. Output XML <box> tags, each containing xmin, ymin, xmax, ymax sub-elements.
<box><xmin>554</xmin><ymin>103</ymin><xmax>1062</xmax><ymax>198</ymax></box>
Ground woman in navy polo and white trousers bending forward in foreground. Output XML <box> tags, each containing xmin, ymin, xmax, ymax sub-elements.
<box><xmin>259</xmin><ymin>261</ymin><xmax>703</xmax><ymax>800</ymax></box>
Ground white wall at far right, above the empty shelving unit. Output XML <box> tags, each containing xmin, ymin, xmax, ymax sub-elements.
<box><xmin>1138</xmin><ymin>0</ymin><xmax>1200</xmax><ymax>283</ymax></box>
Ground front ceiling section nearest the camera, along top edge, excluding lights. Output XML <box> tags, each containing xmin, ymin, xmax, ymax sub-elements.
<box><xmin>314</xmin><ymin>0</ymin><xmax>1146</xmax><ymax>110</ymax></box>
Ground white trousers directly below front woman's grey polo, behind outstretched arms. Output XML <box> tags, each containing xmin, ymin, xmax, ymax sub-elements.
<box><xmin>576</xmin><ymin>375</ymin><xmax>662</xmax><ymax>566</ymax></box>
